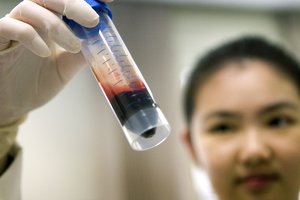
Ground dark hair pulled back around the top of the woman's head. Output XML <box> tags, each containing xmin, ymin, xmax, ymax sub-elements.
<box><xmin>183</xmin><ymin>36</ymin><xmax>300</xmax><ymax>124</ymax></box>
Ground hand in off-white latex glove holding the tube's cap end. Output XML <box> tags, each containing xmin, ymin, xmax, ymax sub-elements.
<box><xmin>0</xmin><ymin>0</ymin><xmax>112</xmax><ymax>171</ymax></box>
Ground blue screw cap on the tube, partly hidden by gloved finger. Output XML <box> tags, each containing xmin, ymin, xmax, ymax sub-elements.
<box><xmin>63</xmin><ymin>0</ymin><xmax>112</xmax><ymax>39</ymax></box>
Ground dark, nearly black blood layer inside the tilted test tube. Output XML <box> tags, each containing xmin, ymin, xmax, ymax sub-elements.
<box><xmin>110</xmin><ymin>89</ymin><xmax>155</xmax><ymax>126</ymax></box>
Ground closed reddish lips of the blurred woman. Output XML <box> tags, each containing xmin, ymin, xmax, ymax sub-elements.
<box><xmin>237</xmin><ymin>173</ymin><xmax>279</xmax><ymax>191</ymax></box>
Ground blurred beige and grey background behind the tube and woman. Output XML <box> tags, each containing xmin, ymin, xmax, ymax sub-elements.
<box><xmin>0</xmin><ymin>0</ymin><xmax>300</xmax><ymax>200</ymax></box>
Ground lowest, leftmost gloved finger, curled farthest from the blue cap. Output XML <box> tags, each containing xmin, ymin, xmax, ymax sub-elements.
<box><xmin>0</xmin><ymin>17</ymin><xmax>51</xmax><ymax>57</ymax></box>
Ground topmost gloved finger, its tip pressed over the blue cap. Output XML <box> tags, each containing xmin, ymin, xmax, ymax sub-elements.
<box><xmin>31</xmin><ymin>0</ymin><xmax>99</xmax><ymax>27</ymax></box>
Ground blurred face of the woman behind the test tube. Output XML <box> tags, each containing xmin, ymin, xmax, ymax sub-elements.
<box><xmin>190</xmin><ymin>60</ymin><xmax>300</xmax><ymax>200</ymax></box>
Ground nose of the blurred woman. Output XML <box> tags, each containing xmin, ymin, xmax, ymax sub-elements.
<box><xmin>239</xmin><ymin>129</ymin><xmax>272</xmax><ymax>167</ymax></box>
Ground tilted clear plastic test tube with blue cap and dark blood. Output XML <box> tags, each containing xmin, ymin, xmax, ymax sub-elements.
<box><xmin>64</xmin><ymin>0</ymin><xmax>170</xmax><ymax>151</ymax></box>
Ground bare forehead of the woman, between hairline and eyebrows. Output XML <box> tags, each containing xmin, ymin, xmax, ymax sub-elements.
<box><xmin>195</xmin><ymin>60</ymin><xmax>299</xmax><ymax>115</ymax></box>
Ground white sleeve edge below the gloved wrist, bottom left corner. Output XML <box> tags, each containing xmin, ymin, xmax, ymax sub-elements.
<box><xmin>0</xmin><ymin>146</ymin><xmax>22</xmax><ymax>200</ymax></box>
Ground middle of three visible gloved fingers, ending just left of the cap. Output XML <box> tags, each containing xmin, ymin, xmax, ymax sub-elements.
<box><xmin>9</xmin><ymin>1</ymin><xmax>81</xmax><ymax>53</ymax></box>
